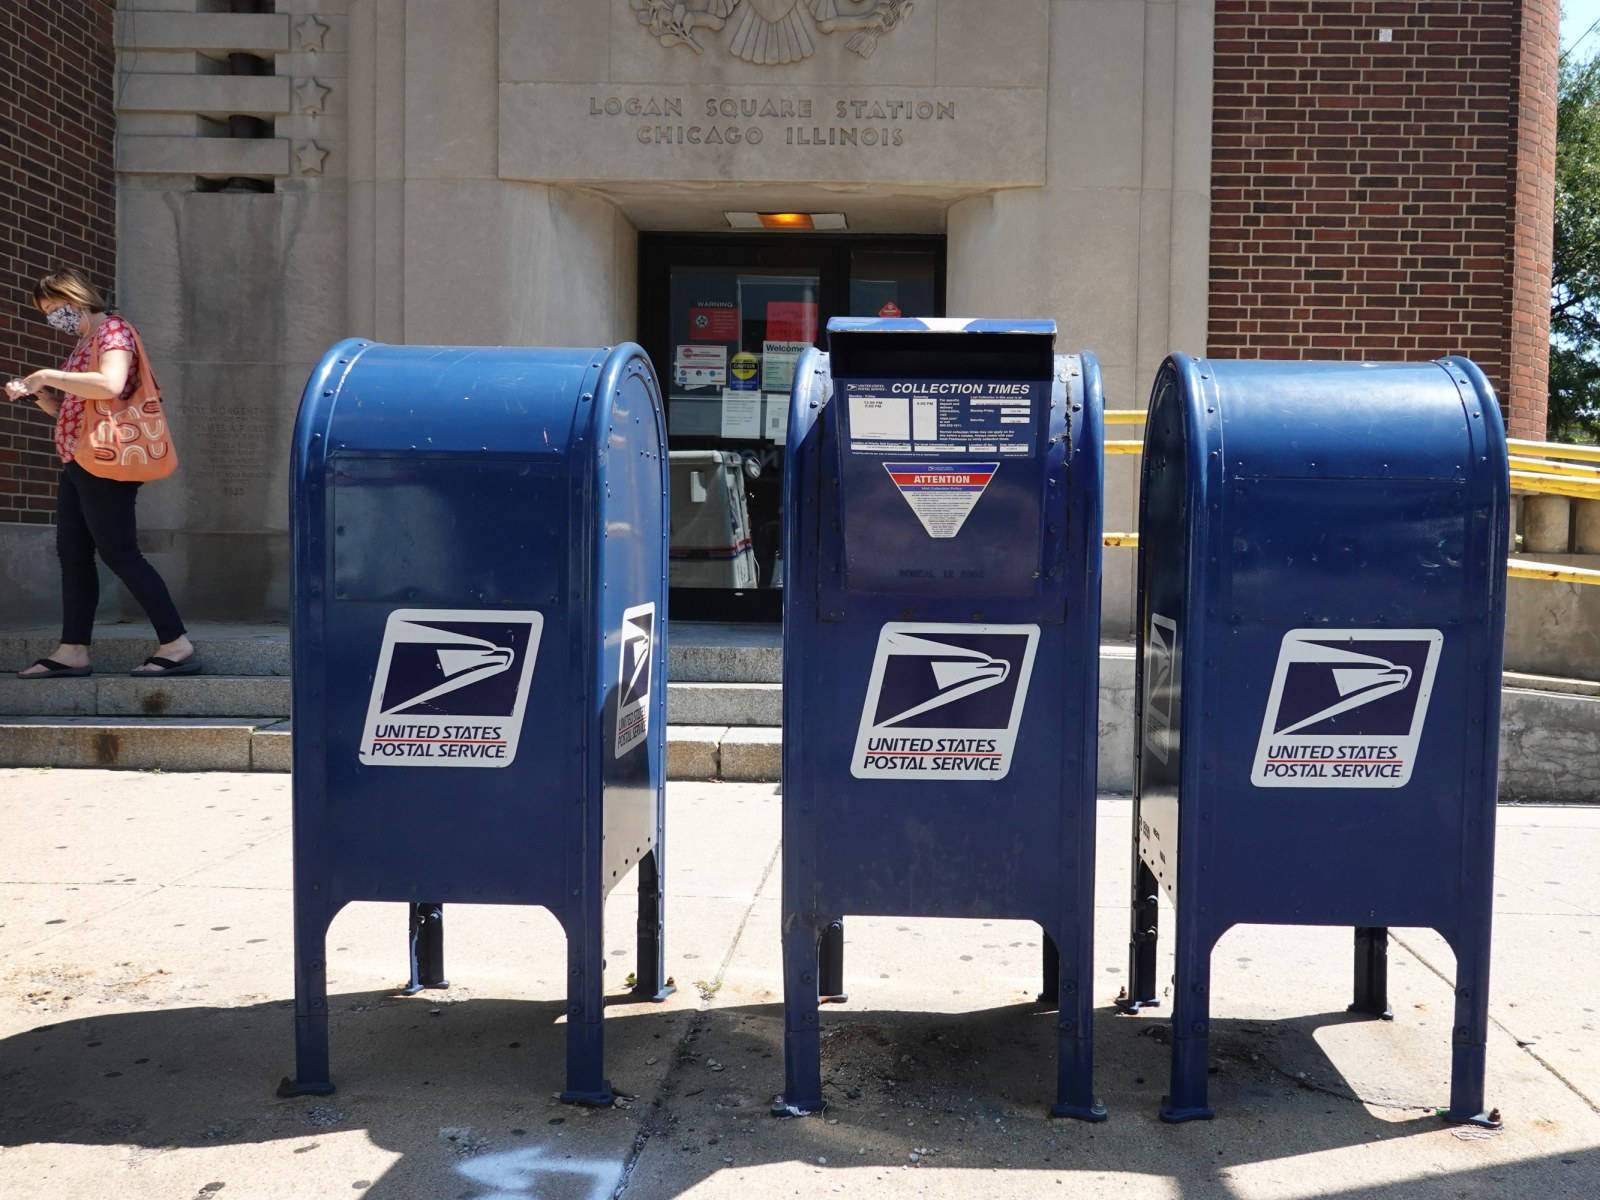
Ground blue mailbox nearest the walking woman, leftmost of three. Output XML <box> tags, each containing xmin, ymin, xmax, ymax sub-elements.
<box><xmin>280</xmin><ymin>341</ymin><xmax>667</xmax><ymax>1104</ymax></box>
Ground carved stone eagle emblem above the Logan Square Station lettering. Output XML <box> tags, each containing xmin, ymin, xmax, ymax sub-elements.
<box><xmin>632</xmin><ymin>0</ymin><xmax>912</xmax><ymax>66</ymax></box>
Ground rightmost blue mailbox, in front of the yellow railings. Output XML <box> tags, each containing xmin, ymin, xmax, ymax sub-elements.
<box><xmin>1125</xmin><ymin>355</ymin><xmax>1509</xmax><ymax>1125</ymax></box>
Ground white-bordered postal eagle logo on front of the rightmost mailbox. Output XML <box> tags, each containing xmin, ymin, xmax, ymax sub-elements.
<box><xmin>1250</xmin><ymin>629</ymin><xmax>1445</xmax><ymax>787</ymax></box>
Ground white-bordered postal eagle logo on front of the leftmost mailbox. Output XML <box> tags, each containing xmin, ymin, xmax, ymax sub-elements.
<box><xmin>360</xmin><ymin>608</ymin><xmax>544</xmax><ymax>766</ymax></box>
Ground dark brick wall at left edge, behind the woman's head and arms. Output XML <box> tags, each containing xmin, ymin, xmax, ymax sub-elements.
<box><xmin>0</xmin><ymin>0</ymin><xmax>117</xmax><ymax>523</ymax></box>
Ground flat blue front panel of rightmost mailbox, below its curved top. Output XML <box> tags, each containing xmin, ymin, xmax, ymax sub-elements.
<box><xmin>1198</xmin><ymin>478</ymin><xmax>1482</xmax><ymax>925</ymax></box>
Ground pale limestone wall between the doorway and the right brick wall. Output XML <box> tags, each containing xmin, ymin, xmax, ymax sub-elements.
<box><xmin>947</xmin><ymin>0</ymin><xmax>1211</xmax><ymax>638</ymax></box>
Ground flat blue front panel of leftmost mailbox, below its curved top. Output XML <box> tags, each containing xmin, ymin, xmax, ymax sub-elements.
<box><xmin>312</xmin><ymin>454</ymin><xmax>582</xmax><ymax>902</ymax></box>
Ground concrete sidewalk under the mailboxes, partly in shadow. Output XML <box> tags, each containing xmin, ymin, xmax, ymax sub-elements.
<box><xmin>0</xmin><ymin>770</ymin><xmax>1600</xmax><ymax>1200</ymax></box>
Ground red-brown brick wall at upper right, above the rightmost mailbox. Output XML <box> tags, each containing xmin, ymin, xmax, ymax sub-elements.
<box><xmin>1208</xmin><ymin>0</ymin><xmax>1558</xmax><ymax>437</ymax></box>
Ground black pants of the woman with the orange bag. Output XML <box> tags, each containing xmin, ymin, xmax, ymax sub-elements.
<box><xmin>56</xmin><ymin>462</ymin><xmax>184</xmax><ymax>646</ymax></box>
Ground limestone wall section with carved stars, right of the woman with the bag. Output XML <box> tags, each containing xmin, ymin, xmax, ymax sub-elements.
<box><xmin>117</xmin><ymin>0</ymin><xmax>347</xmax><ymax>619</ymax></box>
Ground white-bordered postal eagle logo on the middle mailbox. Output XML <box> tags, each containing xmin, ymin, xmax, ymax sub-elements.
<box><xmin>850</xmin><ymin>621</ymin><xmax>1038</xmax><ymax>781</ymax></box>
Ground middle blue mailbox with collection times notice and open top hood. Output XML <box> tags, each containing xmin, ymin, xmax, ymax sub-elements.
<box><xmin>774</xmin><ymin>318</ymin><xmax>1106</xmax><ymax>1120</ymax></box>
